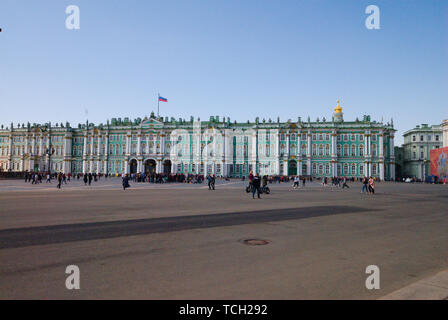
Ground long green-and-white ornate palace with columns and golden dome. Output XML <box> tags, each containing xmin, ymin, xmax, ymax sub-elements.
<box><xmin>0</xmin><ymin>101</ymin><xmax>396</xmax><ymax>180</ymax></box>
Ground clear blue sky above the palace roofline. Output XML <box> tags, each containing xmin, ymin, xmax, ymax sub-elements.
<box><xmin>0</xmin><ymin>0</ymin><xmax>448</xmax><ymax>144</ymax></box>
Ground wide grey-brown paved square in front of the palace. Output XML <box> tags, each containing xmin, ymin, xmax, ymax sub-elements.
<box><xmin>0</xmin><ymin>178</ymin><xmax>448</xmax><ymax>299</ymax></box>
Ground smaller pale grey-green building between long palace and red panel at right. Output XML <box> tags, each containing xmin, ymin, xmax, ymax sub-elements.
<box><xmin>402</xmin><ymin>124</ymin><xmax>443</xmax><ymax>180</ymax></box>
